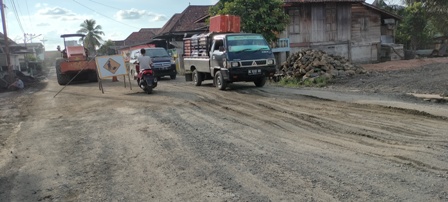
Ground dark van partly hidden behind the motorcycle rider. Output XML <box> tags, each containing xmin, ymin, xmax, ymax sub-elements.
<box><xmin>129</xmin><ymin>48</ymin><xmax>177</xmax><ymax>79</ymax></box>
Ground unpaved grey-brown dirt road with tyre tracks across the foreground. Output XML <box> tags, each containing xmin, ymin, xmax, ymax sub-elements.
<box><xmin>0</xmin><ymin>67</ymin><xmax>448</xmax><ymax>201</ymax></box>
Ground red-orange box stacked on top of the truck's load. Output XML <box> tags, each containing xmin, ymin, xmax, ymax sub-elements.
<box><xmin>209</xmin><ymin>15</ymin><xmax>241</xmax><ymax>33</ymax></box>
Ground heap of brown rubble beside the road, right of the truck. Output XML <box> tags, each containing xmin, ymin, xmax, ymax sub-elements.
<box><xmin>280</xmin><ymin>49</ymin><xmax>366</xmax><ymax>80</ymax></box>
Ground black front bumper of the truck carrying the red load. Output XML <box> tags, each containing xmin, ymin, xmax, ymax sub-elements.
<box><xmin>228</xmin><ymin>66</ymin><xmax>276</xmax><ymax>82</ymax></box>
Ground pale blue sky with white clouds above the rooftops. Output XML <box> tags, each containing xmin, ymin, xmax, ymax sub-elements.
<box><xmin>3</xmin><ymin>0</ymin><xmax>396</xmax><ymax>50</ymax></box>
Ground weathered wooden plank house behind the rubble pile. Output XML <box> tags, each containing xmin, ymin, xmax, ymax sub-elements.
<box><xmin>280</xmin><ymin>0</ymin><xmax>400</xmax><ymax>63</ymax></box>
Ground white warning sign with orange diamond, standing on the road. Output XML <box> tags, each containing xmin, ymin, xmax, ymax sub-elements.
<box><xmin>95</xmin><ymin>55</ymin><xmax>127</xmax><ymax>79</ymax></box>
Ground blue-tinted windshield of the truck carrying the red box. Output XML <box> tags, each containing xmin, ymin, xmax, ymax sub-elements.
<box><xmin>227</xmin><ymin>35</ymin><xmax>270</xmax><ymax>53</ymax></box>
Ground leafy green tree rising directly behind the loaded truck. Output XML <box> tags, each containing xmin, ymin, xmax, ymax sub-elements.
<box><xmin>210</xmin><ymin>0</ymin><xmax>289</xmax><ymax>42</ymax></box>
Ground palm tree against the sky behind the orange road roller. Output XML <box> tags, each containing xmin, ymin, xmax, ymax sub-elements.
<box><xmin>77</xmin><ymin>19</ymin><xmax>104</xmax><ymax>55</ymax></box>
